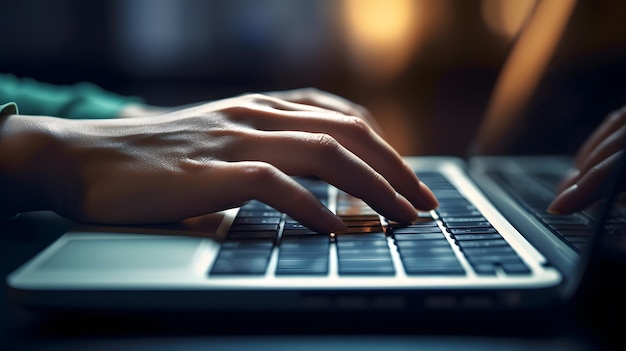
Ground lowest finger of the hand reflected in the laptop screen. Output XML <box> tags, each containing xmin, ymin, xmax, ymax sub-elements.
<box><xmin>547</xmin><ymin>151</ymin><xmax>623</xmax><ymax>214</ymax></box>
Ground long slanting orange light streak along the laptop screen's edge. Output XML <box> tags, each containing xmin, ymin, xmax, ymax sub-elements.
<box><xmin>474</xmin><ymin>0</ymin><xmax>575</xmax><ymax>153</ymax></box>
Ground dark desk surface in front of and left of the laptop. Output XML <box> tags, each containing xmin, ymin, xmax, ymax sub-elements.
<box><xmin>0</xmin><ymin>212</ymin><xmax>616</xmax><ymax>351</ymax></box>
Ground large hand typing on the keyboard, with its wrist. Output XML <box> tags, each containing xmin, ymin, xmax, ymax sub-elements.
<box><xmin>0</xmin><ymin>91</ymin><xmax>437</xmax><ymax>231</ymax></box>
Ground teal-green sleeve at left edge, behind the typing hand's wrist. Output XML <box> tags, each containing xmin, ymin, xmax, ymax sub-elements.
<box><xmin>0</xmin><ymin>74</ymin><xmax>143</xmax><ymax>119</ymax></box>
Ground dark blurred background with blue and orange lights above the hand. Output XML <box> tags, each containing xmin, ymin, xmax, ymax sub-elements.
<box><xmin>0</xmin><ymin>0</ymin><xmax>626</xmax><ymax>156</ymax></box>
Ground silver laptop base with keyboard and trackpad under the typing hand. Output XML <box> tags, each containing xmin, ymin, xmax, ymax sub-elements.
<box><xmin>6</xmin><ymin>0</ymin><xmax>624</xmax><ymax>312</ymax></box>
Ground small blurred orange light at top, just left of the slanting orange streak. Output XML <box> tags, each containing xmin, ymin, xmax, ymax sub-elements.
<box><xmin>482</xmin><ymin>0</ymin><xmax>538</xmax><ymax>38</ymax></box>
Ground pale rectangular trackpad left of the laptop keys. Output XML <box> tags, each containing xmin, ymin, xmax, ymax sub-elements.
<box><xmin>38</xmin><ymin>237</ymin><xmax>202</xmax><ymax>271</ymax></box>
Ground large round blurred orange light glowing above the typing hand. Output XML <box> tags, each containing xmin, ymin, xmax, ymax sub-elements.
<box><xmin>342</xmin><ymin>0</ymin><xmax>434</xmax><ymax>81</ymax></box>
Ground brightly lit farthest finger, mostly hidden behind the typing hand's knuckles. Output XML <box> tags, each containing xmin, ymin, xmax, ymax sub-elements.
<box><xmin>266</xmin><ymin>88</ymin><xmax>384</xmax><ymax>137</ymax></box>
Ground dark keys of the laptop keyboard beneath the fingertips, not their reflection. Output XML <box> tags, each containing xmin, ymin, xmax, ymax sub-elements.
<box><xmin>209</xmin><ymin>172</ymin><xmax>531</xmax><ymax>276</ymax></box>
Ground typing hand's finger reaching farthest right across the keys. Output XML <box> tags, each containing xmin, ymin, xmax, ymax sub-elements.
<box><xmin>236</xmin><ymin>111</ymin><xmax>438</xmax><ymax>211</ymax></box>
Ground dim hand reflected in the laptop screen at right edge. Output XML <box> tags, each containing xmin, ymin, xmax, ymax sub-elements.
<box><xmin>548</xmin><ymin>106</ymin><xmax>626</xmax><ymax>214</ymax></box>
